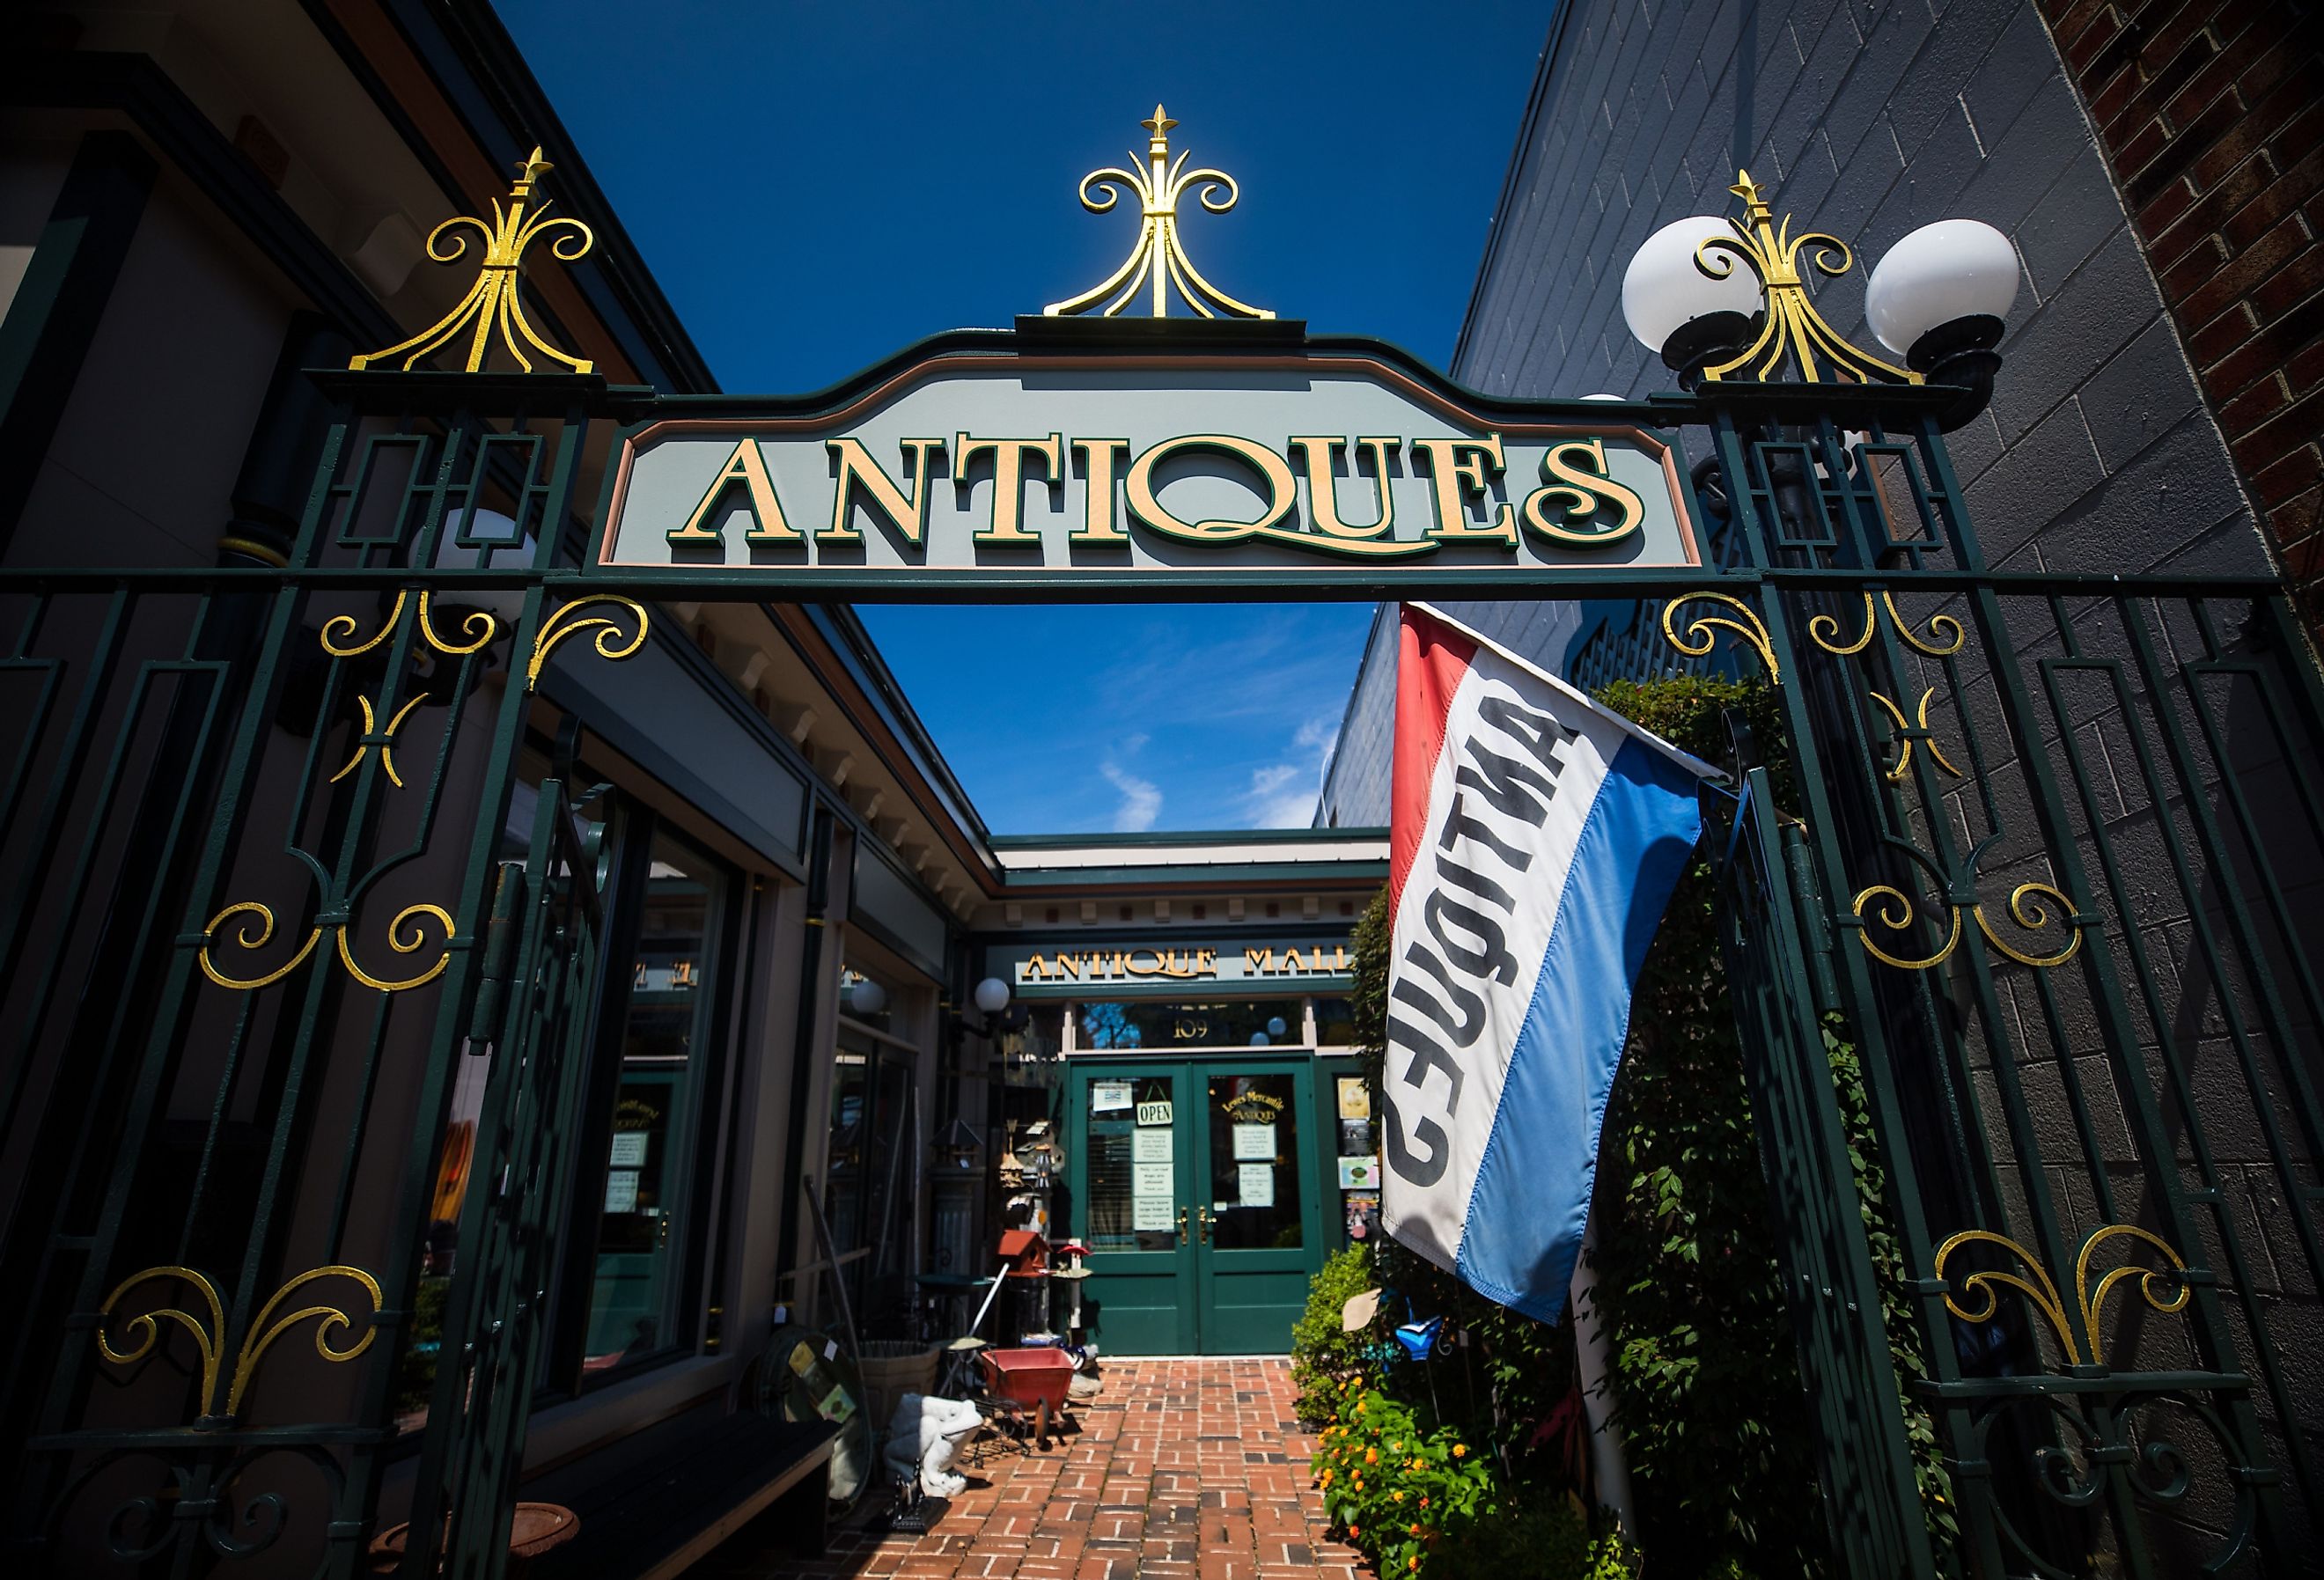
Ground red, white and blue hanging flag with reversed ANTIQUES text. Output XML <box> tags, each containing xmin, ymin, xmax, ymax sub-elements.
<box><xmin>1380</xmin><ymin>604</ymin><xmax>1717</xmax><ymax>1322</ymax></box>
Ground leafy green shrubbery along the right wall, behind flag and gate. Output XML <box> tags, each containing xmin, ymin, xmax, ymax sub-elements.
<box><xmin>1318</xmin><ymin>676</ymin><xmax>1953</xmax><ymax>1580</ymax></box>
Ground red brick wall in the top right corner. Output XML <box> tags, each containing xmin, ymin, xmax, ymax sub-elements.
<box><xmin>2041</xmin><ymin>0</ymin><xmax>2324</xmax><ymax>635</ymax></box>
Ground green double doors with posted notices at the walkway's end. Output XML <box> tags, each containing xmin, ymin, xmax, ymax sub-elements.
<box><xmin>1067</xmin><ymin>1057</ymin><xmax>1329</xmax><ymax>1355</ymax></box>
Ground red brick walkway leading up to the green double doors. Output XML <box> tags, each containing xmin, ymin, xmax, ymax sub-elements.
<box><xmin>695</xmin><ymin>1359</ymin><xmax>1362</xmax><ymax>1580</ymax></box>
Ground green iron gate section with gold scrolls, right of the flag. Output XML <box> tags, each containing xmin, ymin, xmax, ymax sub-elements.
<box><xmin>1576</xmin><ymin>388</ymin><xmax>2324</xmax><ymax>1577</ymax></box>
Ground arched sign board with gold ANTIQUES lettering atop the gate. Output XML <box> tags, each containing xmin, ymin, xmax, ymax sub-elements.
<box><xmin>595</xmin><ymin>346</ymin><xmax>1701</xmax><ymax>588</ymax></box>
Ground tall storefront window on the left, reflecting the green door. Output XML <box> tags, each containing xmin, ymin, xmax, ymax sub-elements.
<box><xmin>581</xmin><ymin>834</ymin><xmax>725</xmax><ymax>1376</ymax></box>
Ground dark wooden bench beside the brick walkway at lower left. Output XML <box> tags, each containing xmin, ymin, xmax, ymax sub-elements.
<box><xmin>523</xmin><ymin>1410</ymin><xmax>839</xmax><ymax>1580</ymax></box>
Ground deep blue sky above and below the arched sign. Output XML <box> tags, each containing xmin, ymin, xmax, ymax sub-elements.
<box><xmin>497</xmin><ymin>0</ymin><xmax>1548</xmax><ymax>834</ymax></box>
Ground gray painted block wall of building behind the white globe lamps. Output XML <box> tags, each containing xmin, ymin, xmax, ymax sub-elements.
<box><xmin>1315</xmin><ymin>0</ymin><xmax>2273</xmax><ymax>827</ymax></box>
